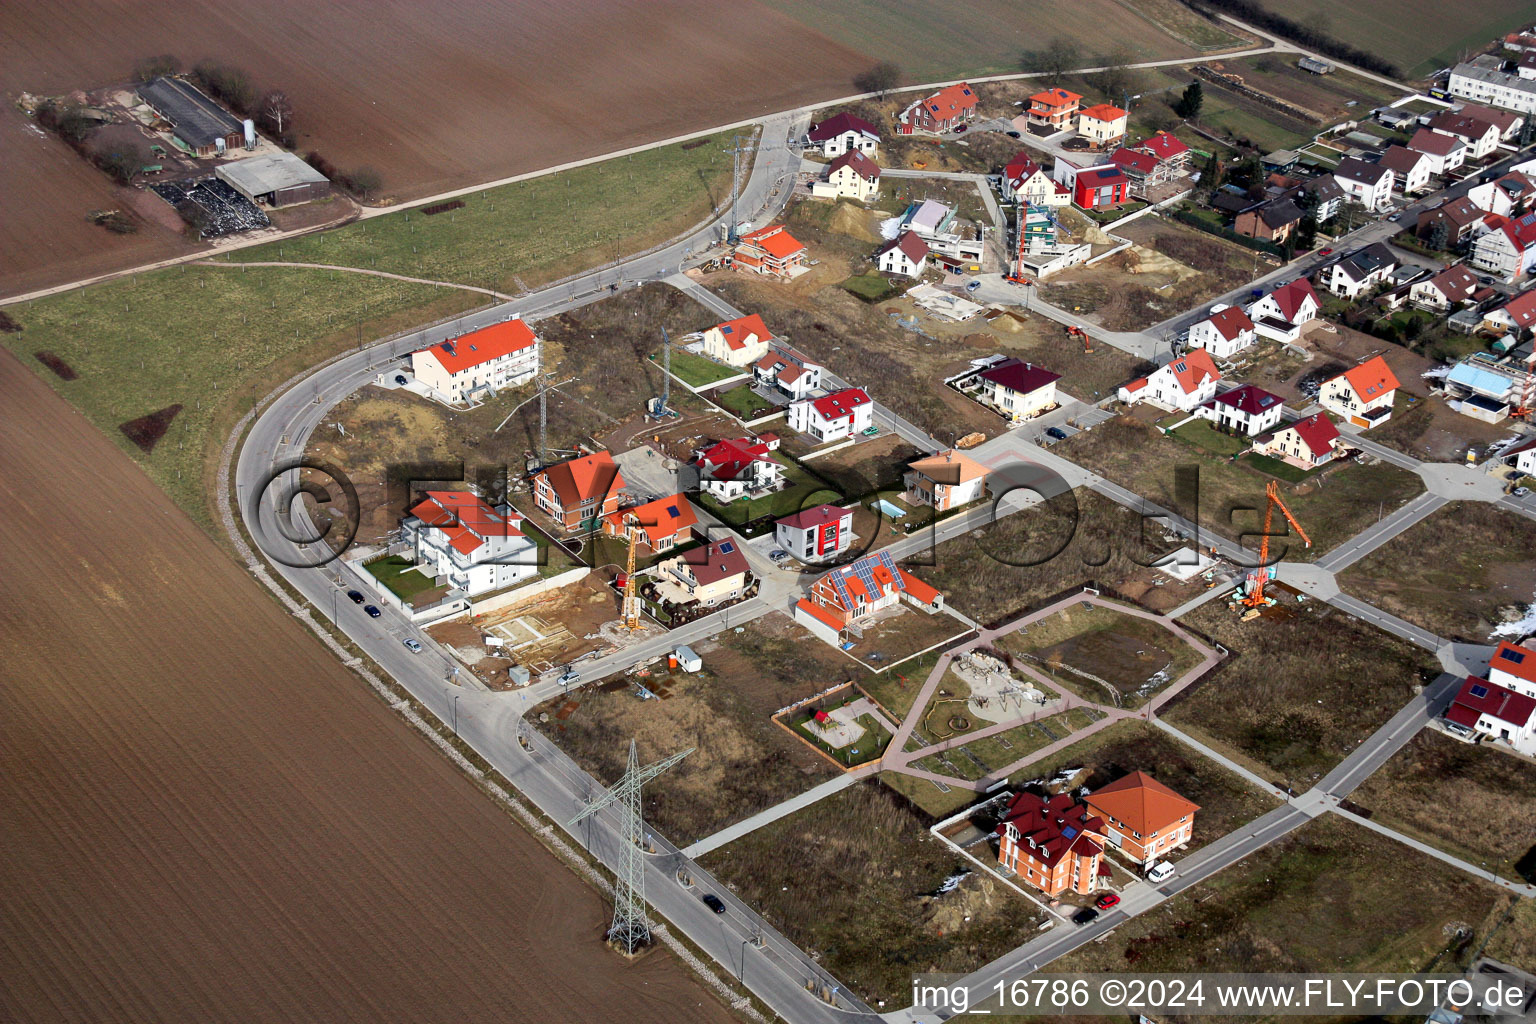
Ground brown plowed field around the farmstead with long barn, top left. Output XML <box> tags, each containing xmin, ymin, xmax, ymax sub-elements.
<box><xmin>0</xmin><ymin>0</ymin><xmax>874</xmax><ymax>293</ymax></box>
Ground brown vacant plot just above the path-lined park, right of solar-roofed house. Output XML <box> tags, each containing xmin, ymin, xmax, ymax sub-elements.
<box><xmin>908</xmin><ymin>488</ymin><xmax>1177</xmax><ymax>626</ymax></box>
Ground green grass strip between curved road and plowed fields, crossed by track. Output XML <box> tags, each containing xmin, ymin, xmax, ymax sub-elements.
<box><xmin>5</xmin><ymin>138</ymin><xmax>743</xmax><ymax>533</ymax></box>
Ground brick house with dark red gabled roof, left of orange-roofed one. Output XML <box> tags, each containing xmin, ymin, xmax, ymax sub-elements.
<box><xmin>997</xmin><ymin>792</ymin><xmax>1111</xmax><ymax>897</ymax></box>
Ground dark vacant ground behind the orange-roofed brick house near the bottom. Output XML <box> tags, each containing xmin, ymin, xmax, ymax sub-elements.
<box><xmin>1011</xmin><ymin>718</ymin><xmax>1275</xmax><ymax>849</ymax></box>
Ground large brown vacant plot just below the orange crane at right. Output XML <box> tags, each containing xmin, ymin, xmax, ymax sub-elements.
<box><xmin>1163</xmin><ymin>586</ymin><xmax>1439</xmax><ymax>792</ymax></box>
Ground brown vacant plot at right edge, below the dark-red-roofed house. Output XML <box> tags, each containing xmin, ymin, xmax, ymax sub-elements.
<box><xmin>1350</xmin><ymin>729</ymin><xmax>1536</xmax><ymax>881</ymax></box>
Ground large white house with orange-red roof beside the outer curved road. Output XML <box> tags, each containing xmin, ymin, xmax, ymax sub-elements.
<box><xmin>401</xmin><ymin>491</ymin><xmax>539</xmax><ymax>597</ymax></box>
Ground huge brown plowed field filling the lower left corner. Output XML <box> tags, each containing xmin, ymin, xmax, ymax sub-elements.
<box><xmin>0</xmin><ymin>352</ymin><xmax>733</xmax><ymax>1024</ymax></box>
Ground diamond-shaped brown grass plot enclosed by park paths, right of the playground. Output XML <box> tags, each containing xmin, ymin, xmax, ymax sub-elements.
<box><xmin>998</xmin><ymin>605</ymin><xmax>1200</xmax><ymax>708</ymax></box>
